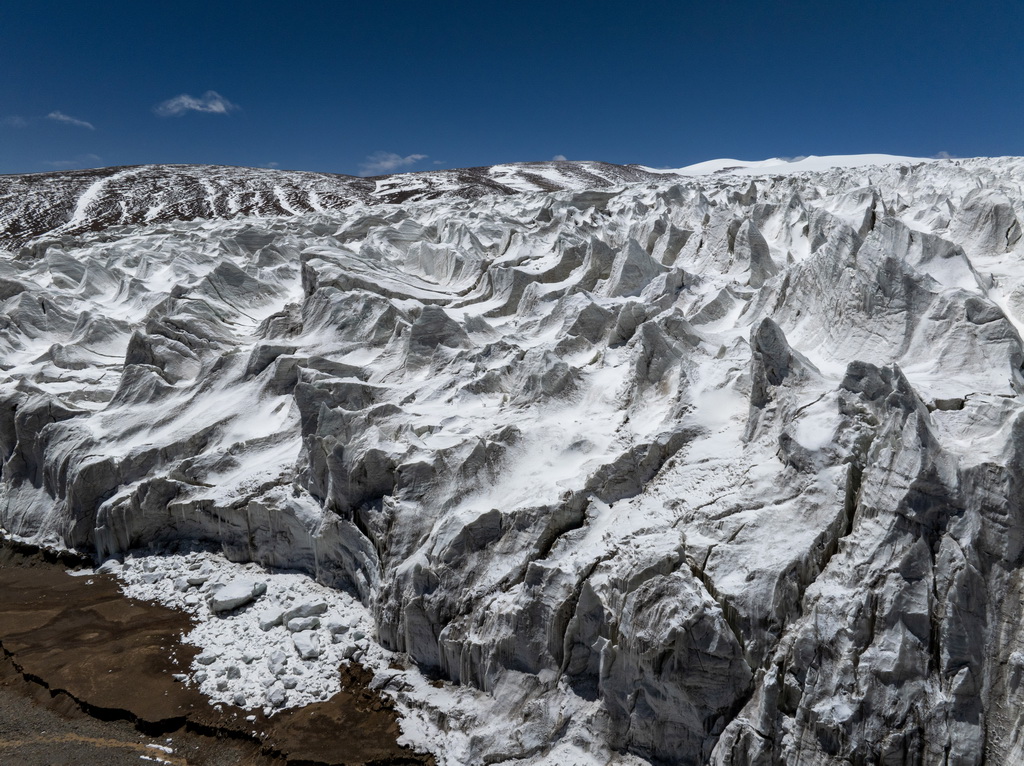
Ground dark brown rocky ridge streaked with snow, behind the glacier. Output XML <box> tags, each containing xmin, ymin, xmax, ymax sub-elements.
<box><xmin>0</xmin><ymin>162</ymin><xmax>659</xmax><ymax>250</ymax></box>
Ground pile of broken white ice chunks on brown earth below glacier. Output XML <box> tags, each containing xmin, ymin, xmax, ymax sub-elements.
<box><xmin>112</xmin><ymin>550</ymin><xmax>372</xmax><ymax>714</ymax></box>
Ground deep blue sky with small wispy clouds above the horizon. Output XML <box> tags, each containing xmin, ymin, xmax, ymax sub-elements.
<box><xmin>0</xmin><ymin>0</ymin><xmax>1024</xmax><ymax>174</ymax></box>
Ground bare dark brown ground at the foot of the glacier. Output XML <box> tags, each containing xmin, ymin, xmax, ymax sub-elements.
<box><xmin>0</xmin><ymin>545</ymin><xmax>433</xmax><ymax>766</ymax></box>
